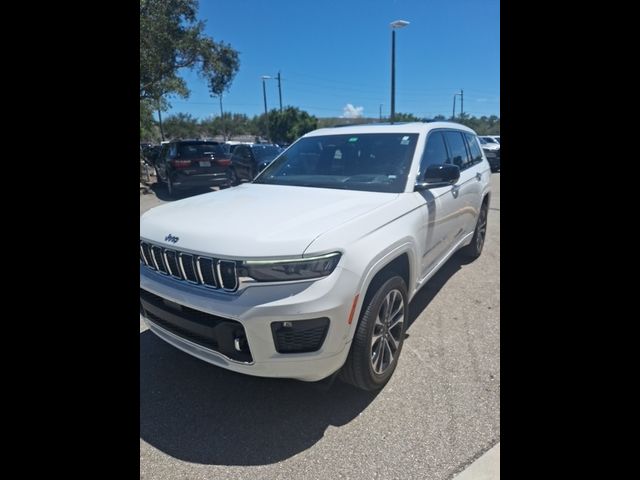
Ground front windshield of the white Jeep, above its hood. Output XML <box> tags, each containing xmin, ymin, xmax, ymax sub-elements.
<box><xmin>254</xmin><ymin>133</ymin><xmax>418</xmax><ymax>193</ymax></box>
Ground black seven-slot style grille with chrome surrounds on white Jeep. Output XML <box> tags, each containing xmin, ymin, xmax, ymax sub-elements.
<box><xmin>140</xmin><ymin>241</ymin><xmax>238</xmax><ymax>292</ymax></box>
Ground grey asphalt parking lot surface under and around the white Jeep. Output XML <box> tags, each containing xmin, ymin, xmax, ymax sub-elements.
<box><xmin>140</xmin><ymin>173</ymin><xmax>500</xmax><ymax>480</ymax></box>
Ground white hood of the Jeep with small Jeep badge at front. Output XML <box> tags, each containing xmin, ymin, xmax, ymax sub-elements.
<box><xmin>140</xmin><ymin>184</ymin><xmax>398</xmax><ymax>258</ymax></box>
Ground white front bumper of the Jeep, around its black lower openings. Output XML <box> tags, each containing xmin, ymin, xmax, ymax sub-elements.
<box><xmin>140</xmin><ymin>265</ymin><xmax>359</xmax><ymax>381</ymax></box>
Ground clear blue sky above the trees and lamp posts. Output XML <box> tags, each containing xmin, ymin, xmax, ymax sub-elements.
<box><xmin>169</xmin><ymin>0</ymin><xmax>500</xmax><ymax>119</ymax></box>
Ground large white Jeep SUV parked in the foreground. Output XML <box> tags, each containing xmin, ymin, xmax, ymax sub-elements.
<box><xmin>140</xmin><ymin>122</ymin><xmax>490</xmax><ymax>390</ymax></box>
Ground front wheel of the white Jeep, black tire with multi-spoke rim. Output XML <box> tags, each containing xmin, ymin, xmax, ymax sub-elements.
<box><xmin>340</xmin><ymin>273</ymin><xmax>409</xmax><ymax>391</ymax></box>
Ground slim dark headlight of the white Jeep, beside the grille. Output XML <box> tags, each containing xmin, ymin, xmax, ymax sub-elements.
<box><xmin>237</xmin><ymin>252</ymin><xmax>341</xmax><ymax>282</ymax></box>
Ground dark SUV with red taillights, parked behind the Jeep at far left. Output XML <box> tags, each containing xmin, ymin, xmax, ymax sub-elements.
<box><xmin>155</xmin><ymin>140</ymin><xmax>232</xmax><ymax>196</ymax></box>
